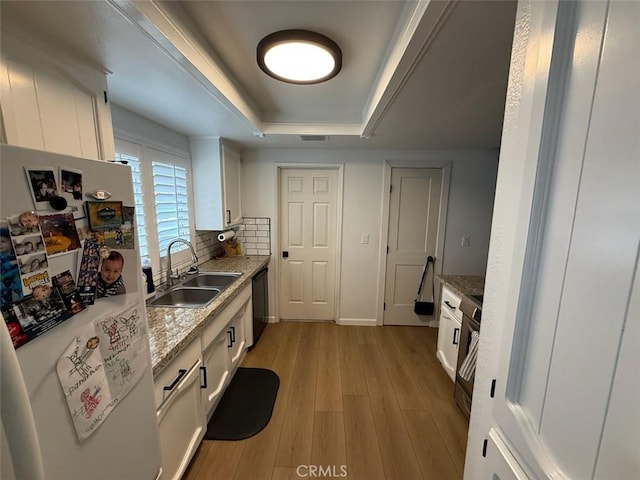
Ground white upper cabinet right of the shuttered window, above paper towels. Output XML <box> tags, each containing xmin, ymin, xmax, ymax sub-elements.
<box><xmin>190</xmin><ymin>137</ymin><xmax>242</xmax><ymax>230</ymax></box>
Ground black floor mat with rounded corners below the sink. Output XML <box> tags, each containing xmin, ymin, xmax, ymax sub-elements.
<box><xmin>204</xmin><ymin>367</ymin><xmax>280</xmax><ymax>440</ymax></box>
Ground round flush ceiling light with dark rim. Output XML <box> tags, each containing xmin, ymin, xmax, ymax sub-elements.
<box><xmin>257</xmin><ymin>30</ymin><xmax>342</xmax><ymax>85</ymax></box>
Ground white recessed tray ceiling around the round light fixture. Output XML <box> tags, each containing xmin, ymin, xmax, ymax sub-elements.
<box><xmin>0</xmin><ymin>0</ymin><xmax>515</xmax><ymax>149</ymax></box>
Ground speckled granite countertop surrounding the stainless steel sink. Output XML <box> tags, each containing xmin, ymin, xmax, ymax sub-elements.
<box><xmin>147</xmin><ymin>255</ymin><xmax>271</xmax><ymax>377</ymax></box>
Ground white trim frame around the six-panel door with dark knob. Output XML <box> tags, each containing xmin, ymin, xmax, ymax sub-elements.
<box><xmin>271</xmin><ymin>162</ymin><xmax>344</xmax><ymax>324</ymax></box>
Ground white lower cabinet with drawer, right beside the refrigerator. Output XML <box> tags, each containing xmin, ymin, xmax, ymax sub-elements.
<box><xmin>154</xmin><ymin>338</ymin><xmax>206</xmax><ymax>480</ymax></box>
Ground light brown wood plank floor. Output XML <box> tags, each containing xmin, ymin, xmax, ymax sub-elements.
<box><xmin>183</xmin><ymin>322</ymin><xmax>468</xmax><ymax>480</ymax></box>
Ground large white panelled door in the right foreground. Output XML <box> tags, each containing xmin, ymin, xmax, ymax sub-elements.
<box><xmin>480</xmin><ymin>1</ymin><xmax>640</xmax><ymax>479</ymax></box>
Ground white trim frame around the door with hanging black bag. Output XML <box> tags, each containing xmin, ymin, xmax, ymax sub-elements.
<box><xmin>376</xmin><ymin>159</ymin><xmax>453</xmax><ymax>326</ymax></box>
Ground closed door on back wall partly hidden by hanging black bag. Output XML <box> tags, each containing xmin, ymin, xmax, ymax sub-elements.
<box><xmin>384</xmin><ymin>168</ymin><xmax>442</xmax><ymax>325</ymax></box>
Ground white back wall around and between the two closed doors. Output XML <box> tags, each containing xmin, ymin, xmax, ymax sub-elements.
<box><xmin>242</xmin><ymin>149</ymin><xmax>498</xmax><ymax>320</ymax></box>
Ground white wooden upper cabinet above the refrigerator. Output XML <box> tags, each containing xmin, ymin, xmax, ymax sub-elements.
<box><xmin>0</xmin><ymin>34</ymin><xmax>114</xmax><ymax>160</ymax></box>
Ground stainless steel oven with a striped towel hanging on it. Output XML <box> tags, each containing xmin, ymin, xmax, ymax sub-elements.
<box><xmin>454</xmin><ymin>296</ymin><xmax>482</xmax><ymax>419</ymax></box>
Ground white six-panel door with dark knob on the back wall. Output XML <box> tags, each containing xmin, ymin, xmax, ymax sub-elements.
<box><xmin>280</xmin><ymin>169</ymin><xmax>338</xmax><ymax>320</ymax></box>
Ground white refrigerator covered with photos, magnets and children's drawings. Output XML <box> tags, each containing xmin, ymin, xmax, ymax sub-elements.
<box><xmin>0</xmin><ymin>145</ymin><xmax>161</xmax><ymax>480</ymax></box>
